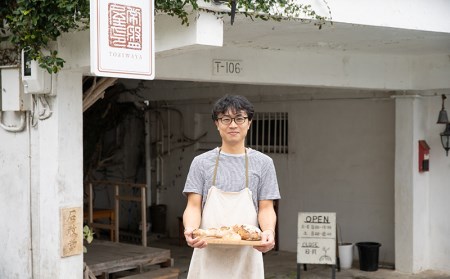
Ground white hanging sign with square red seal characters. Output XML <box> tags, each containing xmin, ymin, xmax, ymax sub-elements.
<box><xmin>90</xmin><ymin>0</ymin><xmax>155</xmax><ymax>79</ymax></box>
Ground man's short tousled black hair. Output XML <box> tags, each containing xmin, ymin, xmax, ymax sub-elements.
<box><xmin>212</xmin><ymin>95</ymin><xmax>255</xmax><ymax>121</ymax></box>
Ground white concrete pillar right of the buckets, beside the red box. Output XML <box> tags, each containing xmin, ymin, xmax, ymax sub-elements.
<box><xmin>395</xmin><ymin>96</ymin><xmax>429</xmax><ymax>273</ymax></box>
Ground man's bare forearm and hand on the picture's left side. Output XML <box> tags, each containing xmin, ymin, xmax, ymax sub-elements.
<box><xmin>183</xmin><ymin>193</ymin><xmax>206</xmax><ymax>248</ymax></box>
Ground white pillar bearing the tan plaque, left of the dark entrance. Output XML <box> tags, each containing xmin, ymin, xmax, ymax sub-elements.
<box><xmin>30</xmin><ymin>70</ymin><xmax>83</xmax><ymax>279</ymax></box>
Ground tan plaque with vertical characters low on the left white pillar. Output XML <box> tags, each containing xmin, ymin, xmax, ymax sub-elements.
<box><xmin>60</xmin><ymin>207</ymin><xmax>83</xmax><ymax>257</ymax></box>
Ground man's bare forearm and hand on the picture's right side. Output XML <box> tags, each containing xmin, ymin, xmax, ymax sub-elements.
<box><xmin>255</xmin><ymin>200</ymin><xmax>277</xmax><ymax>253</ymax></box>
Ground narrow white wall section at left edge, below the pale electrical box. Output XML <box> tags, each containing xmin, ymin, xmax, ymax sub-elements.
<box><xmin>0</xmin><ymin>112</ymin><xmax>32</xmax><ymax>278</ymax></box>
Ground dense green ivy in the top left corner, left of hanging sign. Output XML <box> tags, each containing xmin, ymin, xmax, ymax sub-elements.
<box><xmin>0</xmin><ymin>0</ymin><xmax>89</xmax><ymax>73</ymax></box>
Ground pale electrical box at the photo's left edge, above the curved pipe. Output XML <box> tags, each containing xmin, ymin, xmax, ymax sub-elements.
<box><xmin>0</xmin><ymin>68</ymin><xmax>31</xmax><ymax>111</ymax></box>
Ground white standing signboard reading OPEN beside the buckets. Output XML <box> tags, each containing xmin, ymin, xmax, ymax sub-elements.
<box><xmin>297</xmin><ymin>212</ymin><xmax>336</xmax><ymax>265</ymax></box>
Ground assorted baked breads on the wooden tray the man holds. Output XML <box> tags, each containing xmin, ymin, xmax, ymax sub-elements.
<box><xmin>193</xmin><ymin>225</ymin><xmax>261</xmax><ymax>240</ymax></box>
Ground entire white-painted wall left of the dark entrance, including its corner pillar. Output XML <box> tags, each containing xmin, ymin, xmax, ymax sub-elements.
<box><xmin>0</xmin><ymin>32</ymin><xmax>84</xmax><ymax>278</ymax></box>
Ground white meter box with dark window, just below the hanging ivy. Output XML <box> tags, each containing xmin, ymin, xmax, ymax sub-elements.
<box><xmin>21</xmin><ymin>50</ymin><xmax>52</xmax><ymax>94</ymax></box>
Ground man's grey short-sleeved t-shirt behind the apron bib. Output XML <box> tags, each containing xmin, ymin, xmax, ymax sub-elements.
<box><xmin>183</xmin><ymin>148</ymin><xmax>280</xmax><ymax>211</ymax></box>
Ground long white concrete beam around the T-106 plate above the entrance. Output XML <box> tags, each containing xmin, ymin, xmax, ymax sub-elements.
<box><xmin>156</xmin><ymin>47</ymin><xmax>450</xmax><ymax>90</ymax></box>
